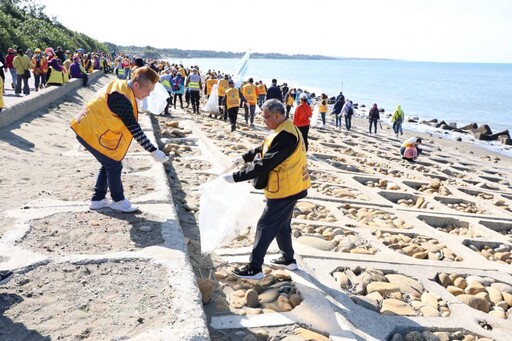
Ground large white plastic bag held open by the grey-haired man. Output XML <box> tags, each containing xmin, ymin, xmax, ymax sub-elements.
<box><xmin>199</xmin><ymin>177</ymin><xmax>264</xmax><ymax>253</ymax></box>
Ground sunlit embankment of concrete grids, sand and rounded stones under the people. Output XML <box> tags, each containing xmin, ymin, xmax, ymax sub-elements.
<box><xmin>0</xmin><ymin>70</ymin><xmax>512</xmax><ymax>341</ymax></box>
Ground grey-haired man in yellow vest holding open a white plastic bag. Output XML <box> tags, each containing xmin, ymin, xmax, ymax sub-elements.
<box><xmin>223</xmin><ymin>99</ymin><xmax>311</xmax><ymax>279</ymax></box>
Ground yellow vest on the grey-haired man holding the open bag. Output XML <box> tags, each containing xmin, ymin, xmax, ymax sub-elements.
<box><xmin>262</xmin><ymin>120</ymin><xmax>311</xmax><ymax>199</ymax></box>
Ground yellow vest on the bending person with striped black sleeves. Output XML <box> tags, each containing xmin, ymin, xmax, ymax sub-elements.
<box><xmin>71</xmin><ymin>80</ymin><xmax>138</xmax><ymax>161</ymax></box>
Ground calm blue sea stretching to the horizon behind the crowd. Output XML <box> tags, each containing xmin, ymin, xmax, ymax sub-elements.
<box><xmin>169</xmin><ymin>58</ymin><xmax>512</xmax><ymax>154</ymax></box>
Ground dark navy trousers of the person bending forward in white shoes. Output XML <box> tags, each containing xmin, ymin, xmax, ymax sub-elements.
<box><xmin>76</xmin><ymin>136</ymin><xmax>124</xmax><ymax>201</ymax></box>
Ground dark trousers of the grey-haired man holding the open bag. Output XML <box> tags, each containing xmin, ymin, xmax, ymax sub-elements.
<box><xmin>250</xmin><ymin>199</ymin><xmax>297</xmax><ymax>270</ymax></box>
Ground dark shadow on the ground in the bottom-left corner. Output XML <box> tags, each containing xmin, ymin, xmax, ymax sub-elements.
<box><xmin>0</xmin><ymin>293</ymin><xmax>51</xmax><ymax>341</ymax></box>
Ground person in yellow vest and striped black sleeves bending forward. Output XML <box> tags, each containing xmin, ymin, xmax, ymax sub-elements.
<box><xmin>71</xmin><ymin>67</ymin><xmax>169</xmax><ymax>212</ymax></box>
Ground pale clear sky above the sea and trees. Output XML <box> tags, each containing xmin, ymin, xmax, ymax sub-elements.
<box><xmin>41</xmin><ymin>0</ymin><xmax>512</xmax><ymax>63</ymax></box>
